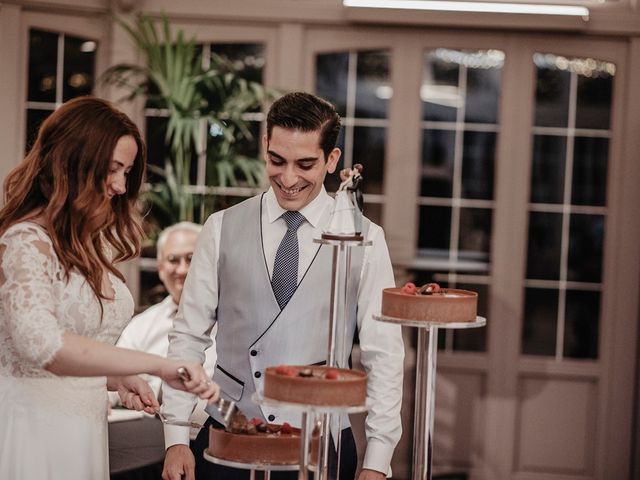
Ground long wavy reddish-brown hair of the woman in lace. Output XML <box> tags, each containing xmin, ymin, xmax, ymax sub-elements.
<box><xmin>0</xmin><ymin>97</ymin><xmax>146</xmax><ymax>303</ymax></box>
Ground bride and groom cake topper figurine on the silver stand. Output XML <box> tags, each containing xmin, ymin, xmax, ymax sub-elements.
<box><xmin>322</xmin><ymin>163</ymin><xmax>364</xmax><ymax>240</ymax></box>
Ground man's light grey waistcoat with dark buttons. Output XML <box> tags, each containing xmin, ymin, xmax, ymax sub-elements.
<box><xmin>207</xmin><ymin>195</ymin><xmax>369</xmax><ymax>428</ymax></box>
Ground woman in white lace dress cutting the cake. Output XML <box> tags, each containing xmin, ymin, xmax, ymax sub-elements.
<box><xmin>0</xmin><ymin>97</ymin><xmax>218</xmax><ymax>480</ymax></box>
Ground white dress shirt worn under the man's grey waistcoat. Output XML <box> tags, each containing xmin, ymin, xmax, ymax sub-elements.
<box><xmin>162</xmin><ymin>188</ymin><xmax>404</xmax><ymax>472</ymax></box>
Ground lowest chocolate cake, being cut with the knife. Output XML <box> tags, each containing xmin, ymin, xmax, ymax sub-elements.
<box><xmin>207</xmin><ymin>418</ymin><xmax>318</xmax><ymax>465</ymax></box>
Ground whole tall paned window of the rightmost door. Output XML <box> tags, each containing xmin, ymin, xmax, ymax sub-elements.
<box><xmin>523</xmin><ymin>53</ymin><xmax>616</xmax><ymax>360</ymax></box>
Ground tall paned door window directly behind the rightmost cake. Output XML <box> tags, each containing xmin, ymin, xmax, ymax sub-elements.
<box><xmin>415</xmin><ymin>48</ymin><xmax>504</xmax><ymax>351</ymax></box>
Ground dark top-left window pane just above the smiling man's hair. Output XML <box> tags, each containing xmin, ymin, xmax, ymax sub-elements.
<box><xmin>316</xmin><ymin>52</ymin><xmax>349</xmax><ymax>117</ymax></box>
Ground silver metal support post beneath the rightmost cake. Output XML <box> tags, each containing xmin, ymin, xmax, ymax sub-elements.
<box><xmin>413</xmin><ymin>327</ymin><xmax>438</xmax><ymax>480</ymax></box>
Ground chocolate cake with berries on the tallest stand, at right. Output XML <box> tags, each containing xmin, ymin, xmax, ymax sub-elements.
<box><xmin>382</xmin><ymin>282</ymin><xmax>478</xmax><ymax>323</ymax></box>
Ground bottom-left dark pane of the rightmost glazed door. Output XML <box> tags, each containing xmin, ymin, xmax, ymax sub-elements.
<box><xmin>522</xmin><ymin>288</ymin><xmax>558</xmax><ymax>356</ymax></box>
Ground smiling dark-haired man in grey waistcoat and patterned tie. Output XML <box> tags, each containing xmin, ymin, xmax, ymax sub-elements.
<box><xmin>163</xmin><ymin>92</ymin><xmax>404</xmax><ymax>480</ymax></box>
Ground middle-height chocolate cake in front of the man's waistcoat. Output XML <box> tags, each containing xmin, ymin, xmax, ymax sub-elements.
<box><xmin>264</xmin><ymin>365</ymin><xmax>367</xmax><ymax>407</ymax></box>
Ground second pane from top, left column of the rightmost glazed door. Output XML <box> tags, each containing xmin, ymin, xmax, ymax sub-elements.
<box><xmin>531</xmin><ymin>135</ymin><xmax>567</xmax><ymax>203</ymax></box>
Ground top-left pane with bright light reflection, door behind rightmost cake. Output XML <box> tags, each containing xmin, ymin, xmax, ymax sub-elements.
<box><xmin>420</xmin><ymin>49</ymin><xmax>462</xmax><ymax>122</ymax></box>
